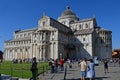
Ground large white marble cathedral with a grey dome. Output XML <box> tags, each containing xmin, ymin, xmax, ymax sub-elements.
<box><xmin>3</xmin><ymin>6</ymin><xmax>112</xmax><ymax>60</ymax></box>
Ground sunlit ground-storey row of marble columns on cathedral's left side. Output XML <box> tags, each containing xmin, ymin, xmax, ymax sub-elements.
<box><xmin>4</xmin><ymin>43</ymin><xmax>57</xmax><ymax>60</ymax></box>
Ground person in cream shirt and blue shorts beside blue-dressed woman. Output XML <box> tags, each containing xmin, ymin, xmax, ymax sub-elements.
<box><xmin>78</xmin><ymin>59</ymin><xmax>87</xmax><ymax>80</ymax></box>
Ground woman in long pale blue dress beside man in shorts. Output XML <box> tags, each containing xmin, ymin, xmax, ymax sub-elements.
<box><xmin>87</xmin><ymin>59</ymin><xmax>95</xmax><ymax>80</ymax></box>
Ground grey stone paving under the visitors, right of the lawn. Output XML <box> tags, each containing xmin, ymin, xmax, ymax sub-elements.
<box><xmin>38</xmin><ymin>63</ymin><xmax>120</xmax><ymax>80</ymax></box>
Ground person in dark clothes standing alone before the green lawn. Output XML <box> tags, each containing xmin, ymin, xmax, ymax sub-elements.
<box><xmin>31</xmin><ymin>57</ymin><xmax>38</xmax><ymax>80</ymax></box>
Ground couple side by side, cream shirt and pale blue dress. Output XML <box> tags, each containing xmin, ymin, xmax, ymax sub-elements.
<box><xmin>78</xmin><ymin>59</ymin><xmax>95</xmax><ymax>80</ymax></box>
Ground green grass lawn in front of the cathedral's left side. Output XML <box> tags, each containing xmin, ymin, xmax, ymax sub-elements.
<box><xmin>0</xmin><ymin>61</ymin><xmax>49</xmax><ymax>78</ymax></box>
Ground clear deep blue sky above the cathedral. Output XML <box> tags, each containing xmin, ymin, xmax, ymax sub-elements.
<box><xmin>0</xmin><ymin>0</ymin><xmax>120</xmax><ymax>51</ymax></box>
